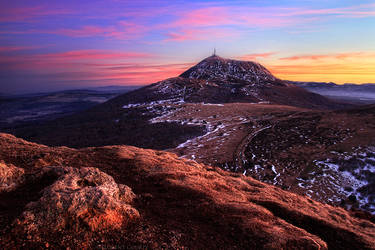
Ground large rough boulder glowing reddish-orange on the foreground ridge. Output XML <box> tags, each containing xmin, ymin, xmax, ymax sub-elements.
<box><xmin>14</xmin><ymin>167</ymin><xmax>139</xmax><ymax>244</ymax></box>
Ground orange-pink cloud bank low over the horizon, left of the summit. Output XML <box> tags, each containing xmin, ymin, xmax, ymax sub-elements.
<box><xmin>0</xmin><ymin>50</ymin><xmax>192</xmax><ymax>84</ymax></box>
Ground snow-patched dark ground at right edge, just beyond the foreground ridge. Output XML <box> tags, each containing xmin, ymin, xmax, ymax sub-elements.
<box><xmin>297</xmin><ymin>147</ymin><xmax>375</xmax><ymax>214</ymax></box>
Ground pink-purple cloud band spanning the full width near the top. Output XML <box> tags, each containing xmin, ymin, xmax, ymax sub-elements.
<box><xmin>0</xmin><ymin>3</ymin><xmax>375</xmax><ymax>42</ymax></box>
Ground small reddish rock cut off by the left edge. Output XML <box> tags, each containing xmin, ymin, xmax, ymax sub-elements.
<box><xmin>0</xmin><ymin>162</ymin><xmax>25</xmax><ymax>193</ymax></box>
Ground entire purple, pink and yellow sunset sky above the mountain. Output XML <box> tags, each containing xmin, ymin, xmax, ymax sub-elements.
<box><xmin>0</xmin><ymin>0</ymin><xmax>375</xmax><ymax>94</ymax></box>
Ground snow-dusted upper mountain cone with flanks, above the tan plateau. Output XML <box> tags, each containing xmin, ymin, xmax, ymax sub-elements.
<box><xmin>103</xmin><ymin>56</ymin><xmax>345</xmax><ymax>109</ymax></box>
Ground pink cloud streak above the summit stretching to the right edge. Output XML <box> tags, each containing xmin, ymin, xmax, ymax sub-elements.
<box><xmin>160</xmin><ymin>5</ymin><xmax>375</xmax><ymax>41</ymax></box>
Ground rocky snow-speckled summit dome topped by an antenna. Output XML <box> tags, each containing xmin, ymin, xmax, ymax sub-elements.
<box><xmin>180</xmin><ymin>55</ymin><xmax>276</xmax><ymax>83</ymax></box>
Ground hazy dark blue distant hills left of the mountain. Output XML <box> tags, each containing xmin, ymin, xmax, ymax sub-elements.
<box><xmin>0</xmin><ymin>86</ymin><xmax>137</xmax><ymax>127</ymax></box>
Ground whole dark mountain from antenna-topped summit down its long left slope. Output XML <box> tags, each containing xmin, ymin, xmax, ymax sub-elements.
<box><xmin>3</xmin><ymin>56</ymin><xmax>347</xmax><ymax>149</ymax></box>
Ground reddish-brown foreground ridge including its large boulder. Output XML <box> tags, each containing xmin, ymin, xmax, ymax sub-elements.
<box><xmin>0</xmin><ymin>134</ymin><xmax>375</xmax><ymax>249</ymax></box>
